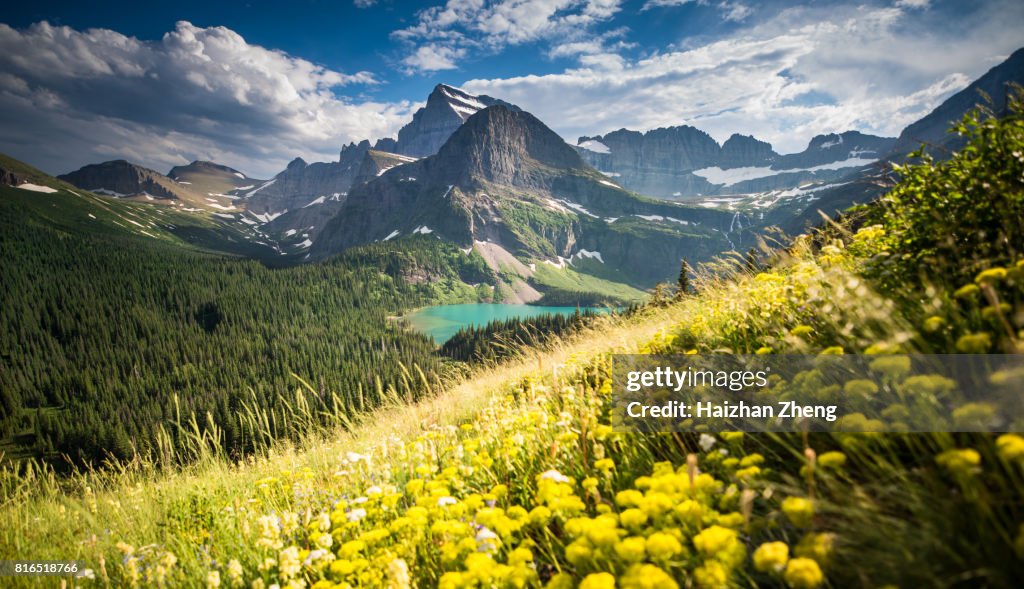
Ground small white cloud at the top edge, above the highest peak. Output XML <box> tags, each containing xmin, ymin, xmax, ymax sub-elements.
<box><xmin>392</xmin><ymin>0</ymin><xmax>622</xmax><ymax>73</ymax></box>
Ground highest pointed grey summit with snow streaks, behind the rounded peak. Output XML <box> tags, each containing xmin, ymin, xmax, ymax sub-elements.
<box><xmin>391</xmin><ymin>84</ymin><xmax>518</xmax><ymax>158</ymax></box>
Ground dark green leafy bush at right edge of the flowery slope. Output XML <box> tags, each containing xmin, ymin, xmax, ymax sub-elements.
<box><xmin>878</xmin><ymin>93</ymin><xmax>1024</xmax><ymax>286</ymax></box>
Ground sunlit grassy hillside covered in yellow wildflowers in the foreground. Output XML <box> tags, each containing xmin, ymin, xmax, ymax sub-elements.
<box><xmin>0</xmin><ymin>95</ymin><xmax>1024</xmax><ymax>589</ymax></box>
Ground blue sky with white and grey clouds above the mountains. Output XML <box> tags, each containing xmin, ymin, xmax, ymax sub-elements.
<box><xmin>0</xmin><ymin>0</ymin><xmax>1024</xmax><ymax>176</ymax></box>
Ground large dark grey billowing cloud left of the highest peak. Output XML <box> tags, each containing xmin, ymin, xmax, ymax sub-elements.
<box><xmin>0</xmin><ymin>22</ymin><xmax>415</xmax><ymax>176</ymax></box>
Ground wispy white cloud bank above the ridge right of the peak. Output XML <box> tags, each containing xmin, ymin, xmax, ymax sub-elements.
<box><xmin>463</xmin><ymin>2</ymin><xmax>1024</xmax><ymax>153</ymax></box>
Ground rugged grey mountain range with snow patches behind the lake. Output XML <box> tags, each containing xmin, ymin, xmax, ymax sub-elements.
<box><xmin>0</xmin><ymin>46</ymin><xmax>1024</xmax><ymax>302</ymax></box>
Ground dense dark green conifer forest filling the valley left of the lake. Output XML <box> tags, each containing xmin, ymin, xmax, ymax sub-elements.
<box><xmin>0</xmin><ymin>199</ymin><xmax>485</xmax><ymax>463</ymax></box>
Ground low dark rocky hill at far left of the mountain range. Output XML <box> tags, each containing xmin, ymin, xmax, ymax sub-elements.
<box><xmin>57</xmin><ymin>160</ymin><xmax>203</xmax><ymax>204</ymax></box>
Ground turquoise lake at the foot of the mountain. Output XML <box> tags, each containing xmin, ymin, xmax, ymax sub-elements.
<box><xmin>406</xmin><ymin>303</ymin><xmax>611</xmax><ymax>343</ymax></box>
